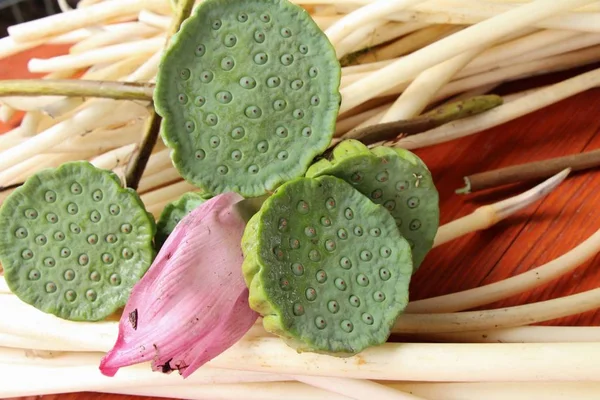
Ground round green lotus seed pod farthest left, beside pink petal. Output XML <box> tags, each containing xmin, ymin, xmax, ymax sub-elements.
<box><xmin>0</xmin><ymin>161</ymin><xmax>156</xmax><ymax>321</ymax></box>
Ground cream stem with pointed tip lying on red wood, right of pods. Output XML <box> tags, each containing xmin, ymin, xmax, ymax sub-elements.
<box><xmin>433</xmin><ymin>169</ymin><xmax>570</xmax><ymax>247</ymax></box>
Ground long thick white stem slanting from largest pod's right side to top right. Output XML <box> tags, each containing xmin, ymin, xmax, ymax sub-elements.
<box><xmin>340</xmin><ymin>0</ymin><xmax>592</xmax><ymax>112</ymax></box>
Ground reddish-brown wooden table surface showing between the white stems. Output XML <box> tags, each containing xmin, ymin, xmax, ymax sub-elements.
<box><xmin>0</xmin><ymin>47</ymin><xmax>600</xmax><ymax>400</ymax></box>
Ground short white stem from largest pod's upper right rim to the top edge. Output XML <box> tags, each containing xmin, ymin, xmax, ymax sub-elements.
<box><xmin>325</xmin><ymin>0</ymin><xmax>423</xmax><ymax>46</ymax></box>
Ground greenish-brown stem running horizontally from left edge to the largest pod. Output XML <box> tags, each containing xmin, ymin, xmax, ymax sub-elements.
<box><xmin>0</xmin><ymin>79</ymin><xmax>154</xmax><ymax>101</ymax></box>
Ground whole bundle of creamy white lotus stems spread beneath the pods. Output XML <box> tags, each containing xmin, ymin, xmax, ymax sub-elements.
<box><xmin>0</xmin><ymin>0</ymin><xmax>600</xmax><ymax>400</ymax></box>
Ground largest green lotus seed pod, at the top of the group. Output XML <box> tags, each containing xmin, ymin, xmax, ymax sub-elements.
<box><xmin>154</xmin><ymin>0</ymin><xmax>341</xmax><ymax>197</ymax></box>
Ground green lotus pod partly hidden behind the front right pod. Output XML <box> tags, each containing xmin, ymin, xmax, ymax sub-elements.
<box><xmin>306</xmin><ymin>140</ymin><xmax>440</xmax><ymax>271</ymax></box>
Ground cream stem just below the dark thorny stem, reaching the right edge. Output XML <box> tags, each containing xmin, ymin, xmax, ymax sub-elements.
<box><xmin>396</xmin><ymin>69</ymin><xmax>600</xmax><ymax>150</ymax></box>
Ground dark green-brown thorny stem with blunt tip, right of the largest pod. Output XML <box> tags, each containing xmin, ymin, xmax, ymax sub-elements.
<box><xmin>344</xmin><ymin>95</ymin><xmax>502</xmax><ymax>145</ymax></box>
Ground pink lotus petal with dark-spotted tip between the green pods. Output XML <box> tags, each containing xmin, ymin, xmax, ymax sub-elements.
<box><xmin>100</xmin><ymin>193</ymin><xmax>258</xmax><ymax>378</ymax></box>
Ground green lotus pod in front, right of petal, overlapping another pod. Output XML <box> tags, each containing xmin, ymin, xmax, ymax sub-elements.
<box><xmin>242</xmin><ymin>176</ymin><xmax>412</xmax><ymax>356</ymax></box>
